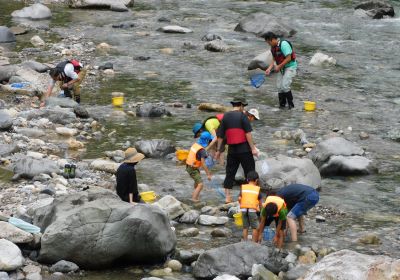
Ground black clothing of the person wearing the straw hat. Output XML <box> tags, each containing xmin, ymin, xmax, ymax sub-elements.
<box><xmin>116</xmin><ymin>163</ymin><xmax>140</xmax><ymax>202</ymax></box>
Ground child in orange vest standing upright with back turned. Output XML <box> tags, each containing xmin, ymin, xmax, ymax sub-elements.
<box><xmin>239</xmin><ymin>171</ymin><xmax>262</xmax><ymax>242</ymax></box>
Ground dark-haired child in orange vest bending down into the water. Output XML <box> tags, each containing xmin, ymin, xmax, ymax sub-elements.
<box><xmin>258</xmin><ymin>195</ymin><xmax>288</xmax><ymax>248</ymax></box>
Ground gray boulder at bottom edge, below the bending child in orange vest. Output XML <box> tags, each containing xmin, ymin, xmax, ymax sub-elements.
<box><xmin>193</xmin><ymin>242</ymin><xmax>287</xmax><ymax>279</ymax></box>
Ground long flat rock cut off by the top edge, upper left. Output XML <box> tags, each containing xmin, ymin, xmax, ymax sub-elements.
<box><xmin>69</xmin><ymin>0</ymin><xmax>134</xmax><ymax>12</ymax></box>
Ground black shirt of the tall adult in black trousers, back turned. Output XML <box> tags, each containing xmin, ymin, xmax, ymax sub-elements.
<box><xmin>217</xmin><ymin>111</ymin><xmax>252</xmax><ymax>154</ymax></box>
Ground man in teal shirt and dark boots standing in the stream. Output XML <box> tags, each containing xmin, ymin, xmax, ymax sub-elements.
<box><xmin>261</xmin><ymin>32</ymin><xmax>297</xmax><ymax>109</ymax></box>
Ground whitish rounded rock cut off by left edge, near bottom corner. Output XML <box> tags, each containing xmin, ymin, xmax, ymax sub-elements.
<box><xmin>0</xmin><ymin>239</ymin><xmax>24</xmax><ymax>271</ymax></box>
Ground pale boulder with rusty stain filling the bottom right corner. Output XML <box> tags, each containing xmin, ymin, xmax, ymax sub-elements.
<box><xmin>302</xmin><ymin>250</ymin><xmax>400</xmax><ymax>280</ymax></box>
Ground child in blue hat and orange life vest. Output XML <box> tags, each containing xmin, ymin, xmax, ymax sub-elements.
<box><xmin>186</xmin><ymin>131</ymin><xmax>214</xmax><ymax>202</ymax></box>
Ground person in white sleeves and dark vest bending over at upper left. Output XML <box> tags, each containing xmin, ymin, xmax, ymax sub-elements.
<box><xmin>40</xmin><ymin>59</ymin><xmax>87</xmax><ymax>107</ymax></box>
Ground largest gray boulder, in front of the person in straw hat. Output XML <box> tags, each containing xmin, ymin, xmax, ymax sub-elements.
<box><xmin>34</xmin><ymin>188</ymin><xmax>176</xmax><ymax>269</ymax></box>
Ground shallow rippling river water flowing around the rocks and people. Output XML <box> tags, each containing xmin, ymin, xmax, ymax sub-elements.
<box><xmin>0</xmin><ymin>0</ymin><xmax>400</xmax><ymax>279</ymax></box>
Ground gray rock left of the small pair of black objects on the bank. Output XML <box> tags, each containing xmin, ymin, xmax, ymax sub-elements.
<box><xmin>12</xmin><ymin>154</ymin><xmax>60</xmax><ymax>179</ymax></box>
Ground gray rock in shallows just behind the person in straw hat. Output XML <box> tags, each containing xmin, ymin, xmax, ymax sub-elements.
<box><xmin>135</xmin><ymin>139</ymin><xmax>175</xmax><ymax>158</ymax></box>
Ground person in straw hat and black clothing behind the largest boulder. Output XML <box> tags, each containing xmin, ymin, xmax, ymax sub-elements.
<box><xmin>116</xmin><ymin>148</ymin><xmax>144</xmax><ymax>204</ymax></box>
